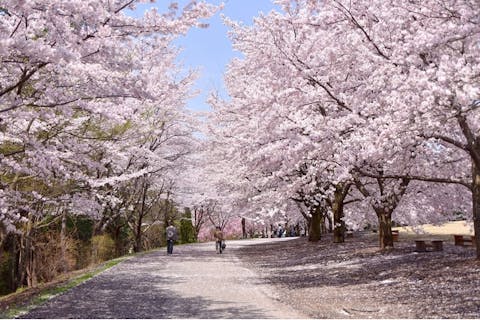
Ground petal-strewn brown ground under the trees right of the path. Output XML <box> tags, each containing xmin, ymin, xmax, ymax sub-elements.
<box><xmin>236</xmin><ymin>232</ymin><xmax>480</xmax><ymax>318</ymax></box>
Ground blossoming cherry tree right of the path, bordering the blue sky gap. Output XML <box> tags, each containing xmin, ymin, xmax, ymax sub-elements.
<box><xmin>210</xmin><ymin>5</ymin><xmax>364</xmax><ymax>242</ymax></box>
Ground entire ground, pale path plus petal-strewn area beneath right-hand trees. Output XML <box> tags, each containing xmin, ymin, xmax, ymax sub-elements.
<box><xmin>11</xmin><ymin>232</ymin><xmax>480</xmax><ymax>319</ymax></box>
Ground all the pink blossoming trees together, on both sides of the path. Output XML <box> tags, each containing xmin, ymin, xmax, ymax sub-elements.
<box><xmin>0</xmin><ymin>0</ymin><xmax>480</xmax><ymax>296</ymax></box>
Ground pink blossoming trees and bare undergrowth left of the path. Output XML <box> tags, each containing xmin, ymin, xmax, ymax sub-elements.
<box><xmin>0</xmin><ymin>0</ymin><xmax>217</xmax><ymax>296</ymax></box>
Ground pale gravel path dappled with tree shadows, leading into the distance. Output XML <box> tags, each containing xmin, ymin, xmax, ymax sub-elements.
<box><xmin>22</xmin><ymin>239</ymin><xmax>305</xmax><ymax>319</ymax></box>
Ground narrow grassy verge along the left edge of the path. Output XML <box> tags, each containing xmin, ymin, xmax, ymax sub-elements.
<box><xmin>0</xmin><ymin>256</ymin><xmax>129</xmax><ymax>319</ymax></box>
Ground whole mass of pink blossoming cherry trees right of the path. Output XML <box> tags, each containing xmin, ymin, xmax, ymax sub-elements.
<box><xmin>199</xmin><ymin>0</ymin><xmax>480</xmax><ymax>258</ymax></box>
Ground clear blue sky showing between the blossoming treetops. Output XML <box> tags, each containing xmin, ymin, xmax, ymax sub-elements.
<box><xmin>136</xmin><ymin>0</ymin><xmax>278</xmax><ymax>111</ymax></box>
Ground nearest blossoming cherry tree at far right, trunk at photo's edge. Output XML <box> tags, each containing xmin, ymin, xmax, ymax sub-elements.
<box><xmin>312</xmin><ymin>1</ymin><xmax>479</xmax><ymax>254</ymax></box>
